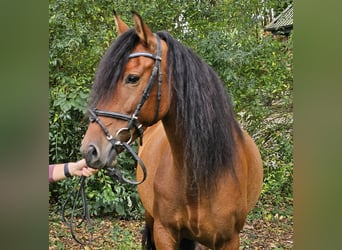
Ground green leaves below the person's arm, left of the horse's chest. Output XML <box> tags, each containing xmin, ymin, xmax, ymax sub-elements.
<box><xmin>50</xmin><ymin>147</ymin><xmax>144</xmax><ymax>219</ymax></box>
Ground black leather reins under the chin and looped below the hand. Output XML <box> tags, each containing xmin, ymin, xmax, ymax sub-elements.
<box><xmin>62</xmin><ymin>142</ymin><xmax>147</xmax><ymax>245</ymax></box>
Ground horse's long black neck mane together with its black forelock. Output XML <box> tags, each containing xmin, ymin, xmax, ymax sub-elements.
<box><xmin>89</xmin><ymin>29</ymin><xmax>241</xmax><ymax>185</ymax></box>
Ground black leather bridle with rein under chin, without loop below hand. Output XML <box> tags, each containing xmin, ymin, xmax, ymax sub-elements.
<box><xmin>88</xmin><ymin>34</ymin><xmax>162</xmax><ymax>185</ymax></box>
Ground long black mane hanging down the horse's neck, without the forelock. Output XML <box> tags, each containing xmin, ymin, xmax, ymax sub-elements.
<box><xmin>157</xmin><ymin>32</ymin><xmax>241</xmax><ymax>185</ymax></box>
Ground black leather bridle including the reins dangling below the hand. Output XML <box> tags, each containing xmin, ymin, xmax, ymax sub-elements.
<box><xmin>62</xmin><ymin>34</ymin><xmax>162</xmax><ymax>245</ymax></box>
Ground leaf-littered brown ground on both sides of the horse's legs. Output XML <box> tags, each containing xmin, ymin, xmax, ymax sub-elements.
<box><xmin>49</xmin><ymin>210</ymin><xmax>293</xmax><ymax>250</ymax></box>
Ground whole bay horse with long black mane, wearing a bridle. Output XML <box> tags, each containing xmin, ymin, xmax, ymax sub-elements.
<box><xmin>81</xmin><ymin>11</ymin><xmax>263</xmax><ymax>250</ymax></box>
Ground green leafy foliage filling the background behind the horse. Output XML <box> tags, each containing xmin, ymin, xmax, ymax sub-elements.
<box><xmin>49</xmin><ymin>0</ymin><xmax>293</xmax><ymax>218</ymax></box>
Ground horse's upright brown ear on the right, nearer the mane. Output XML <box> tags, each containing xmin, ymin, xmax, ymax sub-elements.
<box><xmin>132</xmin><ymin>11</ymin><xmax>156</xmax><ymax>48</ymax></box>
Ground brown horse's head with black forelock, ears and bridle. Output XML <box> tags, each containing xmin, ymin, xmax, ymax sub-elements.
<box><xmin>81</xmin><ymin>12</ymin><xmax>170</xmax><ymax>168</ymax></box>
